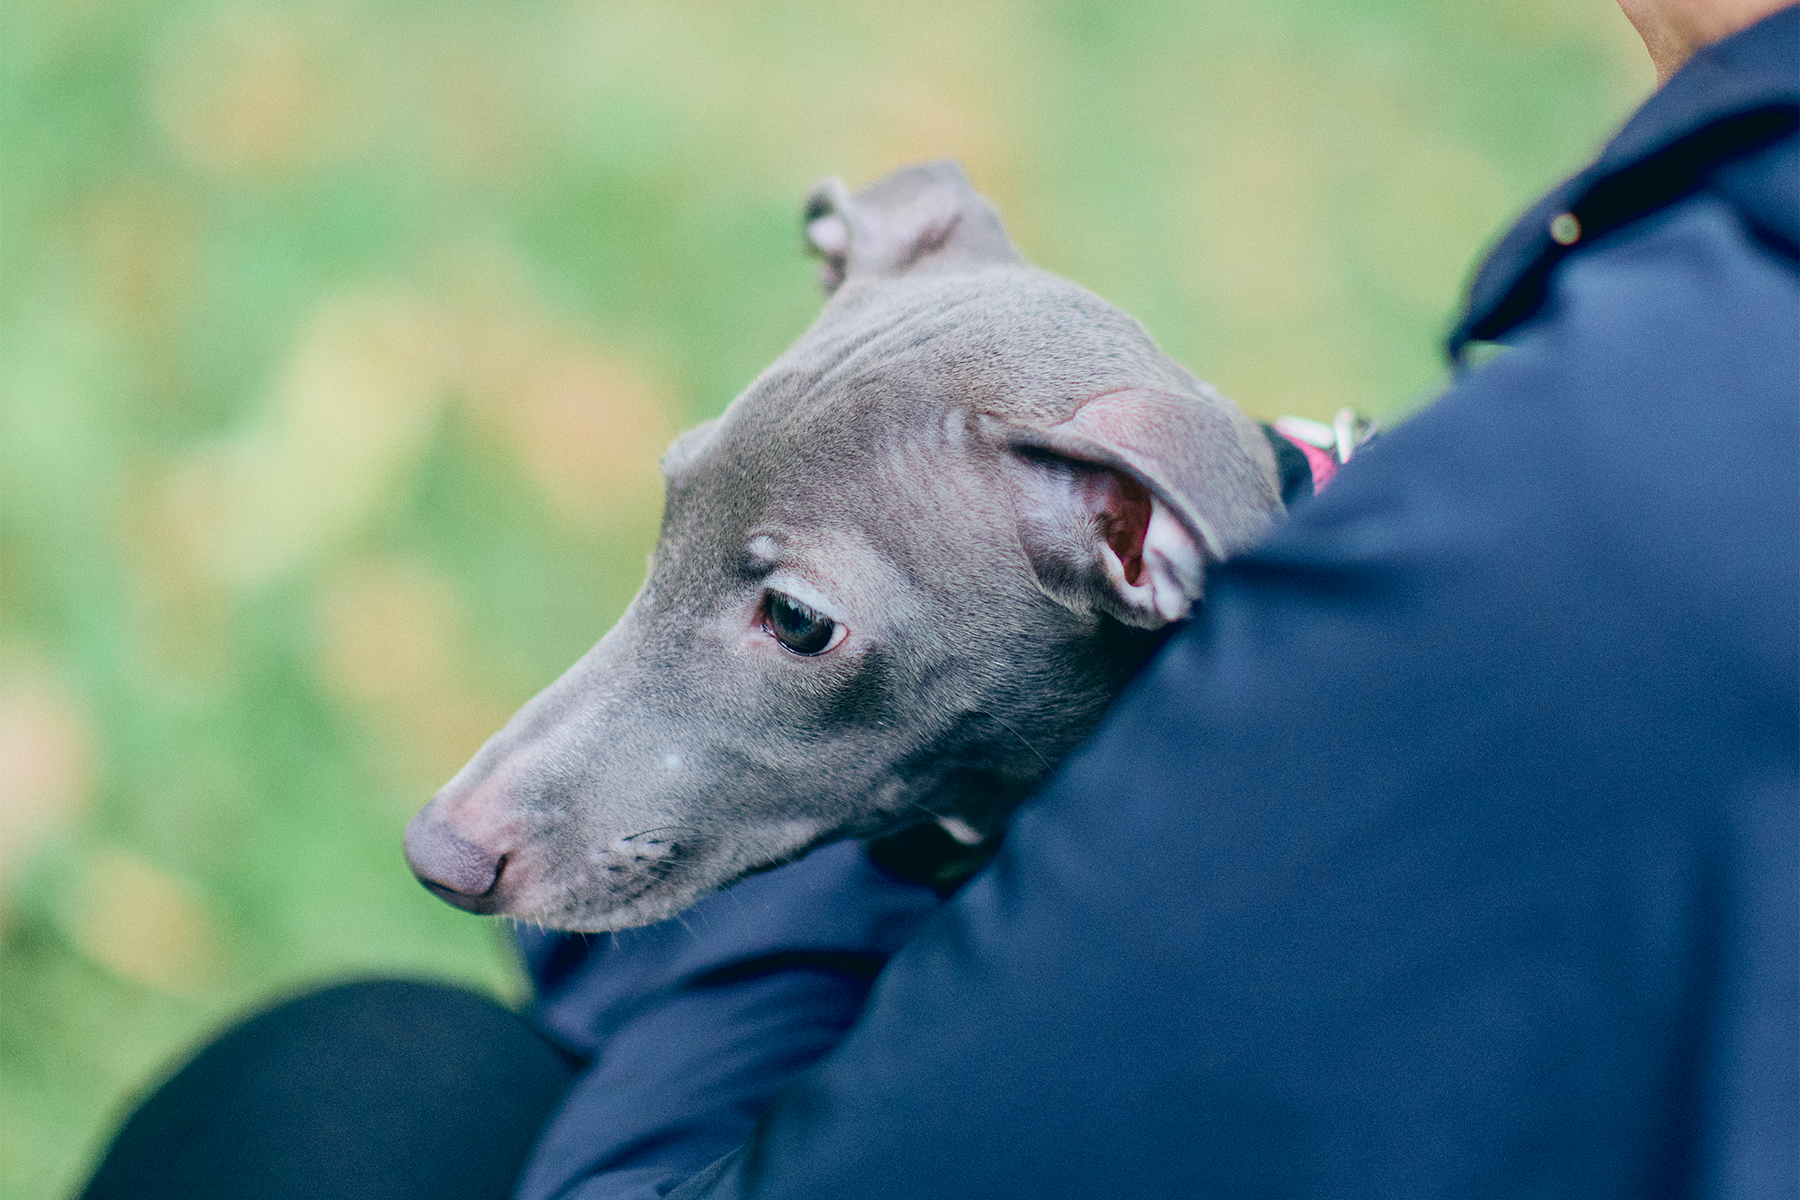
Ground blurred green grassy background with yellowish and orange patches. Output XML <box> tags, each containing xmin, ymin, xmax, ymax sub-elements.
<box><xmin>0</xmin><ymin>0</ymin><xmax>1651</xmax><ymax>1200</ymax></box>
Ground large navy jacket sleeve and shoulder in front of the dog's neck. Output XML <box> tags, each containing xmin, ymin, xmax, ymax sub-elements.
<box><xmin>673</xmin><ymin>183</ymin><xmax>1800</xmax><ymax>1200</ymax></box>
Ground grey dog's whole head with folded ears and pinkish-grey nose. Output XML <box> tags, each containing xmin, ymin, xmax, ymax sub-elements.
<box><xmin>407</xmin><ymin>162</ymin><xmax>1282</xmax><ymax>930</ymax></box>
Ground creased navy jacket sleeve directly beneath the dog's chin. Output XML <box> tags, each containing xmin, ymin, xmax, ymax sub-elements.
<box><xmin>517</xmin><ymin>844</ymin><xmax>940</xmax><ymax>1200</ymax></box>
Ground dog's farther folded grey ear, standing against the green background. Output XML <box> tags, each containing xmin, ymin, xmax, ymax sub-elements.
<box><xmin>801</xmin><ymin>158</ymin><xmax>1024</xmax><ymax>295</ymax></box>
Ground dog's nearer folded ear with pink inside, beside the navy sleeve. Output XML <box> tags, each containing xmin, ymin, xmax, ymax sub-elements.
<box><xmin>988</xmin><ymin>389</ymin><xmax>1282</xmax><ymax>630</ymax></box>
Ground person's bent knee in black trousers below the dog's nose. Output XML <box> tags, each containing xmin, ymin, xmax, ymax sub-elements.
<box><xmin>83</xmin><ymin>981</ymin><xmax>580</xmax><ymax>1200</ymax></box>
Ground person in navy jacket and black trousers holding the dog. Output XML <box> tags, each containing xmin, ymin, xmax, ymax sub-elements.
<box><xmin>77</xmin><ymin>0</ymin><xmax>1800</xmax><ymax>1200</ymax></box>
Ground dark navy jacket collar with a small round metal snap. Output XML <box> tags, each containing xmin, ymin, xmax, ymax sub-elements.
<box><xmin>1449</xmin><ymin>7</ymin><xmax>1800</xmax><ymax>363</ymax></box>
